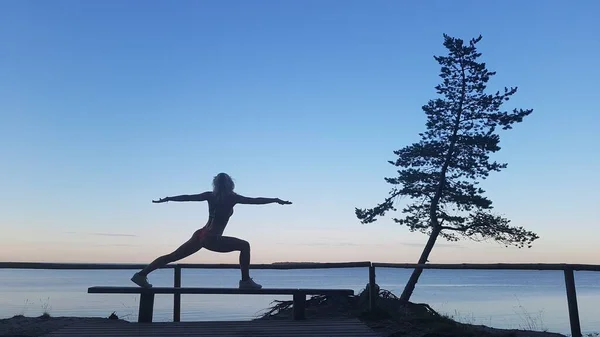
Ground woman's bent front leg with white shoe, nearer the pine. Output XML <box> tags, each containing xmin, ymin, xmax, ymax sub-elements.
<box><xmin>204</xmin><ymin>236</ymin><xmax>262</xmax><ymax>288</ymax></box>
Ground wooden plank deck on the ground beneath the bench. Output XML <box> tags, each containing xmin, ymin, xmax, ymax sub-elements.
<box><xmin>45</xmin><ymin>318</ymin><xmax>381</xmax><ymax>337</ymax></box>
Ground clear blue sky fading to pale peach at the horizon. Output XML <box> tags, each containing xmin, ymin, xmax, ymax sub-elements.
<box><xmin>0</xmin><ymin>0</ymin><xmax>600</xmax><ymax>263</ymax></box>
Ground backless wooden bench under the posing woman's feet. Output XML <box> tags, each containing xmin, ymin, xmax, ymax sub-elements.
<box><xmin>88</xmin><ymin>287</ymin><xmax>354</xmax><ymax>323</ymax></box>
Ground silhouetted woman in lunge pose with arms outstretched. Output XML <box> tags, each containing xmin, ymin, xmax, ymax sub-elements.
<box><xmin>131</xmin><ymin>173</ymin><xmax>291</xmax><ymax>289</ymax></box>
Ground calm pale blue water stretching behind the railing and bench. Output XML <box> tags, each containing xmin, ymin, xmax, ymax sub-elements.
<box><xmin>0</xmin><ymin>268</ymin><xmax>600</xmax><ymax>334</ymax></box>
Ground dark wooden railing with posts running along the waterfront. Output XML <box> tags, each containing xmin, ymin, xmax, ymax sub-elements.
<box><xmin>0</xmin><ymin>261</ymin><xmax>600</xmax><ymax>337</ymax></box>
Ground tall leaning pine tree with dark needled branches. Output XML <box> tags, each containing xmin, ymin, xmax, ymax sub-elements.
<box><xmin>355</xmin><ymin>34</ymin><xmax>539</xmax><ymax>301</ymax></box>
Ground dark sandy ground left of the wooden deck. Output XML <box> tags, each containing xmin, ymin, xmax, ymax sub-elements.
<box><xmin>0</xmin><ymin>316</ymin><xmax>128</xmax><ymax>337</ymax></box>
